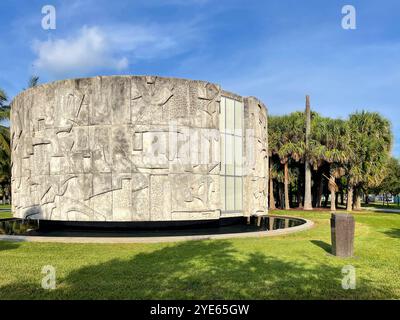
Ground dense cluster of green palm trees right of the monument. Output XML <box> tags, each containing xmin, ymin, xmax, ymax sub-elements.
<box><xmin>268</xmin><ymin>111</ymin><xmax>396</xmax><ymax>210</ymax></box>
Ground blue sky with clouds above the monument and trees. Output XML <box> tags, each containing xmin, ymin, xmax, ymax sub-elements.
<box><xmin>0</xmin><ymin>0</ymin><xmax>400</xmax><ymax>157</ymax></box>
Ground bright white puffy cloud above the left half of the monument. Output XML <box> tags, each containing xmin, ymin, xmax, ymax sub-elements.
<box><xmin>33</xmin><ymin>25</ymin><xmax>185</xmax><ymax>77</ymax></box>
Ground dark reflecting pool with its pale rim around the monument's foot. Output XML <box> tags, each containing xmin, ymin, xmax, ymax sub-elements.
<box><xmin>0</xmin><ymin>215</ymin><xmax>314</xmax><ymax>243</ymax></box>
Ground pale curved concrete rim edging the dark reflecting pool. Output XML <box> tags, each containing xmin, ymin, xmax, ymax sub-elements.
<box><xmin>0</xmin><ymin>215</ymin><xmax>314</xmax><ymax>244</ymax></box>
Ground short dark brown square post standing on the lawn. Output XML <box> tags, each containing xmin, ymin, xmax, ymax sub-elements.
<box><xmin>331</xmin><ymin>213</ymin><xmax>354</xmax><ymax>257</ymax></box>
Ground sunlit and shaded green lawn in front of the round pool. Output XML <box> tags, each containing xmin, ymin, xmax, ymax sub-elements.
<box><xmin>0</xmin><ymin>211</ymin><xmax>400</xmax><ymax>299</ymax></box>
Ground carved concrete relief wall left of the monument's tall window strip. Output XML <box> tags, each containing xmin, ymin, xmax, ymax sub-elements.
<box><xmin>11</xmin><ymin>77</ymin><xmax>247</xmax><ymax>221</ymax></box>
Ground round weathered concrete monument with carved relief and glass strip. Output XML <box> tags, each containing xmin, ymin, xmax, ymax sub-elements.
<box><xmin>11</xmin><ymin>76</ymin><xmax>268</xmax><ymax>224</ymax></box>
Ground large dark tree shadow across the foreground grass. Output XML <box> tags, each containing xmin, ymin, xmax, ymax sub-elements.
<box><xmin>0</xmin><ymin>241</ymin><xmax>393</xmax><ymax>299</ymax></box>
